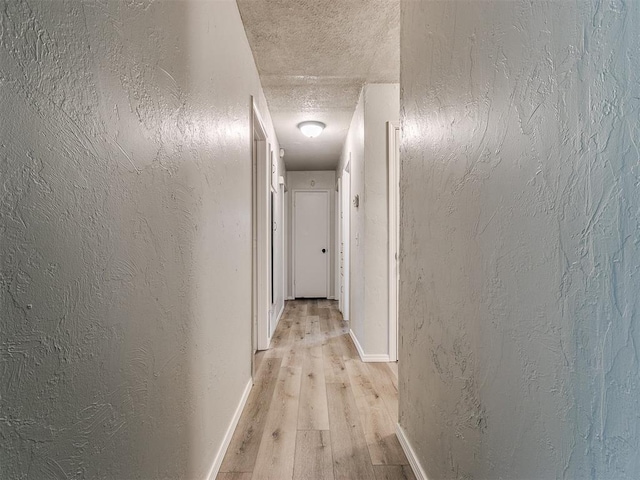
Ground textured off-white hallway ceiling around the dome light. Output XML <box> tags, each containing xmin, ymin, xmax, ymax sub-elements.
<box><xmin>237</xmin><ymin>0</ymin><xmax>400</xmax><ymax>170</ymax></box>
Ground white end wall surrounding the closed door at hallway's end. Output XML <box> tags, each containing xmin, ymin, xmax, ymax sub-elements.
<box><xmin>287</xmin><ymin>170</ymin><xmax>337</xmax><ymax>298</ymax></box>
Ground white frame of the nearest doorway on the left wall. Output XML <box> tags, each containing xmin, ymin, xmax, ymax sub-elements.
<box><xmin>251</xmin><ymin>97</ymin><xmax>271</xmax><ymax>354</ymax></box>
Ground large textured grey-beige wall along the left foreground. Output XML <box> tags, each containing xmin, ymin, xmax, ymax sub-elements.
<box><xmin>0</xmin><ymin>0</ymin><xmax>277</xmax><ymax>479</ymax></box>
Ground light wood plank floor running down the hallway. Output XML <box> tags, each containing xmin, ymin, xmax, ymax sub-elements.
<box><xmin>217</xmin><ymin>300</ymin><xmax>415</xmax><ymax>480</ymax></box>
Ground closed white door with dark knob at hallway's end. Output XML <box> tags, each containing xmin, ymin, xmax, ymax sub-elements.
<box><xmin>293</xmin><ymin>191</ymin><xmax>329</xmax><ymax>298</ymax></box>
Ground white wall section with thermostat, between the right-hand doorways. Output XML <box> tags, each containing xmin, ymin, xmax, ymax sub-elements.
<box><xmin>338</xmin><ymin>84</ymin><xmax>400</xmax><ymax>355</ymax></box>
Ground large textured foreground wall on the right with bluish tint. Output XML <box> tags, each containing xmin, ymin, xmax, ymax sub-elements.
<box><xmin>400</xmin><ymin>0</ymin><xmax>640</xmax><ymax>480</ymax></box>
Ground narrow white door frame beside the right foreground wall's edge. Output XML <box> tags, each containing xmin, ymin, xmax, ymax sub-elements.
<box><xmin>387</xmin><ymin>122</ymin><xmax>400</xmax><ymax>362</ymax></box>
